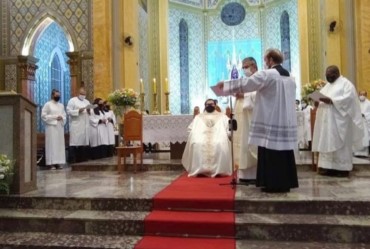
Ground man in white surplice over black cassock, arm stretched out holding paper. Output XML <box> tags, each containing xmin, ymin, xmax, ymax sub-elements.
<box><xmin>217</xmin><ymin>49</ymin><xmax>298</xmax><ymax>192</ymax></box>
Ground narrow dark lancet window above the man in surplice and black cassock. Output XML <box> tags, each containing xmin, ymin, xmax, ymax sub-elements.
<box><xmin>280</xmin><ymin>10</ymin><xmax>292</xmax><ymax>72</ymax></box>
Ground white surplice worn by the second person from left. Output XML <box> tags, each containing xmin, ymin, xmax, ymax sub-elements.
<box><xmin>67</xmin><ymin>97</ymin><xmax>90</xmax><ymax>146</ymax></box>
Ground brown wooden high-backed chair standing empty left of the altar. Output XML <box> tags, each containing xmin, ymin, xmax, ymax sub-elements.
<box><xmin>116</xmin><ymin>110</ymin><xmax>144</xmax><ymax>173</ymax></box>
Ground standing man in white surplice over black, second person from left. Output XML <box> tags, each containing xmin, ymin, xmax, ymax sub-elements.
<box><xmin>67</xmin><ymin>87</ymin><xmax>90</xmax><ymax>163</ymax></box>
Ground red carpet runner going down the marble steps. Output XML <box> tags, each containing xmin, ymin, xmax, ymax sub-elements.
<box><xmin>135</xmin><ymin>174</ymin><xmax>235</xmax><ymax>249</ymax></box>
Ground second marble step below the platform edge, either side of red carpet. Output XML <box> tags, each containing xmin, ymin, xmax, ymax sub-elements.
<box><xmin>0</xmin><ymin>204</ymin><xmax>370</xmax><ymax>243</ymax></box>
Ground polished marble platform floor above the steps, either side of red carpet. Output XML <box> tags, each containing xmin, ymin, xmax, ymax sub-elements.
<box><xmin>28</xmin><ymin>151</ymin><xmax>370</xmax><ymax>200</ymax></box>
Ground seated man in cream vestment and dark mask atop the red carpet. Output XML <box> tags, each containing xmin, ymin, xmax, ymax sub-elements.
<box><xmin>181</xmin><ymin>99</ymin><xmax>232</xmax><ymax>177</ymax></box>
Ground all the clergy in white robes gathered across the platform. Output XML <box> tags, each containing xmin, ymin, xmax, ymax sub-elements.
<box><xmin>41</xmin><ymin>46</ymin><xmax>370</xmax><ymax>193</ymax></box>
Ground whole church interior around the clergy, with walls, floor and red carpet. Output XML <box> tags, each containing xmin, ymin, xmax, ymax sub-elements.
<box><xmin>0</xmin><ymin>0</ymin><xmax>370</xmax><ymax>249</ymax></box>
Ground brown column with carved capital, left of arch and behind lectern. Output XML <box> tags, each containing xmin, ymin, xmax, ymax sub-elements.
<box><xmin>17</xmin><ymin>55</ymin><xmax>39</xmax><ymax>102</ymax></box>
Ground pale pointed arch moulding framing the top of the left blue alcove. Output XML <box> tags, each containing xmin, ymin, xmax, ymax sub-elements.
<box><xmin>21</xmin><ymin>10</ymin><xmax>78</xmax><ymax>56</ymax></box>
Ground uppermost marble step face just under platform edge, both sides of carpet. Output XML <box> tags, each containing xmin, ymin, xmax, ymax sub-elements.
<box><xmin>0</xmin><ymin>195</ymin><xmax>370</xmax><ymax>215</ymax></box>
